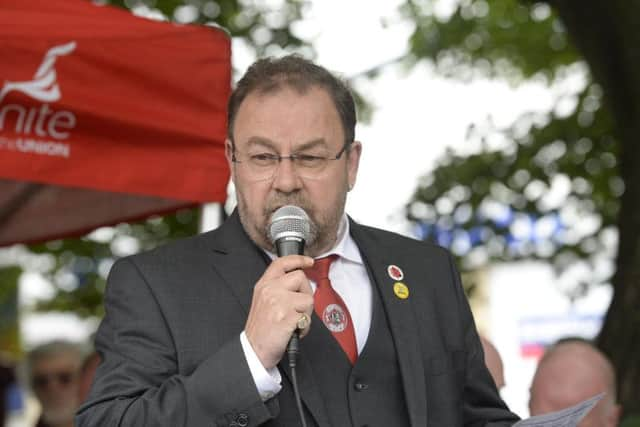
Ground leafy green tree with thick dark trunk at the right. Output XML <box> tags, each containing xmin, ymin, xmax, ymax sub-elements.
<box><xmin>402</xmin><ymin>0</ymin><xmax>640</xmax><ymax>414</ymax></box>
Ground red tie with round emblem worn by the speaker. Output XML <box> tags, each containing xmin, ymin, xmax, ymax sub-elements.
<box><xmin>304</xmin><ymin>255</ymin><xmax>358</xmax><ymax>365</ymax></box>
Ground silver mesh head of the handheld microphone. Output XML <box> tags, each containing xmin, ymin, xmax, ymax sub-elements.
<box><xmin>269</xmin><ymin>205</ymin><xmax>313</xmax><ymax>257</ymax></box>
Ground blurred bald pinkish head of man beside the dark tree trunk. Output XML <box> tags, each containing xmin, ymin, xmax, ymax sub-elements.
<box><xmin>529</xmin><ymin>338</ymin><xmax>620</xmax><ymax>427</ymax></box>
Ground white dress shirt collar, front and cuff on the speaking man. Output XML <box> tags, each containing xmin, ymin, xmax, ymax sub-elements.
<box><xmin>240</xmin><ymin>214</ymin><xmax>373</xmax><ymax>401</ymax></box>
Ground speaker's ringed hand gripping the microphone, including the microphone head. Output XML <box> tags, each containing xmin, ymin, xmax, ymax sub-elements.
<box><xmin>245</xmin><ymin>206</ymin><xmax>313</xmax><ymax>369</ymax></box>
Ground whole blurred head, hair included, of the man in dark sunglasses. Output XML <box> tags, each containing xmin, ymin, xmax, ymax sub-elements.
<box><xmin>27</xmin><ymin>340</ymin><xmax>83</xmax><ymax>427</ymax></box>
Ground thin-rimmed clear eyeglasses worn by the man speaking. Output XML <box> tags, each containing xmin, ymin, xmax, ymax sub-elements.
<box><xmin>231</xmin><ymin>143</ymin><xmax>351</xmax><ymax>181</ymax></box>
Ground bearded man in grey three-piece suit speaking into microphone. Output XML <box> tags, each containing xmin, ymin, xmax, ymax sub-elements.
<box><xmin>77</xmin><ymin>56</ymin><xmax>517</xmax><ymax>427</ymax></box>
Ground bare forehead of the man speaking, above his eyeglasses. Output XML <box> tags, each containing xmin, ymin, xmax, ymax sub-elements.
<box><xmin>233</xmin><ymin>86</ymin><xmax>344</xmax><ymax>148</ymax></box>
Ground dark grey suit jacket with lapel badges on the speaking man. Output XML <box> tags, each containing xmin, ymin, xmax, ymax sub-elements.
<box><xmin>76</xmin><ymin>213</ymin><xmax>517</xmax><ymax>427</ymax></box>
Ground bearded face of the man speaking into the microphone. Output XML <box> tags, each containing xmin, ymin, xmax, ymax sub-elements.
<box><xmin>227</xmin><ymin>87</ymin><xmax>361</xmax><ymax>256</ymax></box>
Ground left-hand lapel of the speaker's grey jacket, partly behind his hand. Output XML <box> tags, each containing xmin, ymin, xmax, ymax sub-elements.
<box><xmin>208</xmin><ymin>211</ymin><xmax>329</xmax><ymax>427</ymax></box>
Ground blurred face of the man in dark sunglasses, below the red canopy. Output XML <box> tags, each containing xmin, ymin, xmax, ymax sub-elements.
<box><xmin>31</xmin><ymin>354</ymin><xmax>79</xmax><ymax>425</ymax></box>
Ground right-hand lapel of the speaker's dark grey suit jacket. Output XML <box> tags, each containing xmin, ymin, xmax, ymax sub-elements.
<box><xmin>350</xmin><ymin>221</ymin><xmax>427</xmax><ymax>426</ymax></box>
